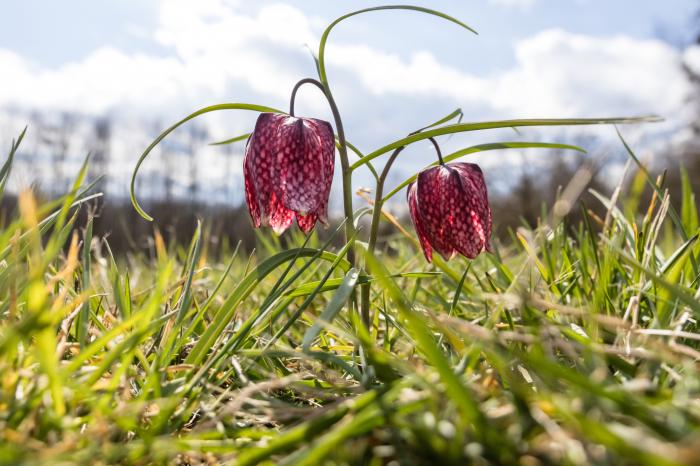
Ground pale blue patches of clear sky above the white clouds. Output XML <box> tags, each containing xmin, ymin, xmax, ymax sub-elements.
<box><xmin>0</xmin><ymin>0</ymin><xmax>698</xmax><ymax>70</ymax></box>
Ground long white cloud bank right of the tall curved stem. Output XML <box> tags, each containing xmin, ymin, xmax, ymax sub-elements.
<box><xmin>329</xmin><ymin>29</ymin><xmax>688</xmax><ymax>121</ymax></box>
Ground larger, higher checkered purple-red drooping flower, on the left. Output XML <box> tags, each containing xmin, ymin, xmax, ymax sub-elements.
<box><xmin>243</xmin><ymin>113</ymin><xmax>335</xmax><ymax>234</ymax></box>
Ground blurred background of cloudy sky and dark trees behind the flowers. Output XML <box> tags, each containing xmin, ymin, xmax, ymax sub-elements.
<box><xmin>0</xmin><ymin>0</ymin><xmax>700</xmax><ymax>250</ymax></box>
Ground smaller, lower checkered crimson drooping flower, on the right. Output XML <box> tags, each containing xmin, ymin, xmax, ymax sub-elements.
<box><xmin>407</xmin><ymin>162</ymin><xmax>492</xmax><ymax>262</ymax></box>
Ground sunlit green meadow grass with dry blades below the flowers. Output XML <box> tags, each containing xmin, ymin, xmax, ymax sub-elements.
<box><xmin>0</xmin><ymin>132</ymin><xmax>700</xmax><ymax>465</ymax></box>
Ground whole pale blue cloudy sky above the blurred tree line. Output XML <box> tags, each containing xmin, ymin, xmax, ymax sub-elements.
<box><xmin>0</xmin><ymin>0</ymin><xmax>700</xmax><ymax>204</ymax></box>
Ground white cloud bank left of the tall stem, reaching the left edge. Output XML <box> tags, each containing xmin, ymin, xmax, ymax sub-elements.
<box><xmin>0</xmin><ymin>0</ymin><xmax>322</xmax><ymax>116</ymax></box>
